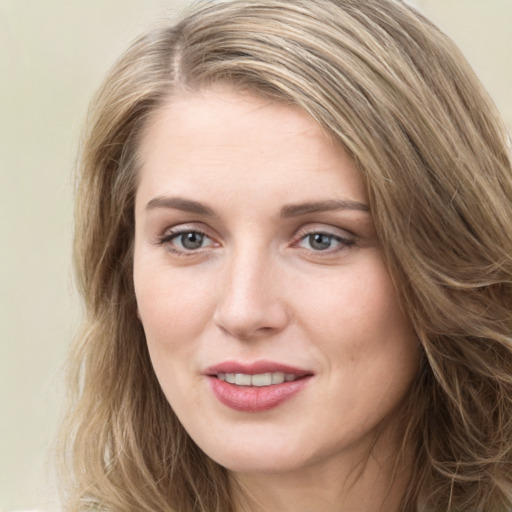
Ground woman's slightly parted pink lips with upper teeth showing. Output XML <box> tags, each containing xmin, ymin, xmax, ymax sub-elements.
<box><xmin>204</xmin><ymin>361</ymin><xmax>313</xmax><ymax>412</ymax></box>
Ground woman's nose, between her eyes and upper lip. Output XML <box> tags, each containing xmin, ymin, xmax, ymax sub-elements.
<box><xmin>214</xmin><ymin>250</ymin><xmax>289</xmax><ymax>340</ymax></box>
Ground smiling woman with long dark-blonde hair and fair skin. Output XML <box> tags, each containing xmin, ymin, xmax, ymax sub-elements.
<box><xmin>63</xmin><ymin>0</ymin><xmax>512</xmax><ymax>512</ymax></box>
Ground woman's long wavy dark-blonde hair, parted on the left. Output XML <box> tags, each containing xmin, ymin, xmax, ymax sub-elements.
<box><xmin>62</xmin><ymin>0</ymin><xmax>512</xmax><ymax>512</ymax></box>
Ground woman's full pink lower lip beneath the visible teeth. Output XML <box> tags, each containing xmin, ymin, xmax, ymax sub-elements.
<box><xmin>208</xmin><ymin>375</ymin><xmax>312</xmax><ymax>412</ymax></box>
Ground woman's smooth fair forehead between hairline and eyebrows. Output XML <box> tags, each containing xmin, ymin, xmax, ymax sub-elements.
<box><xmin>138</xmin><ymin>86</ymin><xmax>365</xmax><ymax>208</ymax></box>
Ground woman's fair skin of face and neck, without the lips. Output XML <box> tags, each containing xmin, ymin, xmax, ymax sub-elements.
<box><xmin>134</xmin><ymin>86</ymin><xmax>419</xmax><ymax>512</ymax></box>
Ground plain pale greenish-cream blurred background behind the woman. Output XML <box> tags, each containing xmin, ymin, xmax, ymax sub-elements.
<box><xmin>0</xmin><ymin>0</ymin><xmax>512</xmax><ymax>512</ymax></box>
